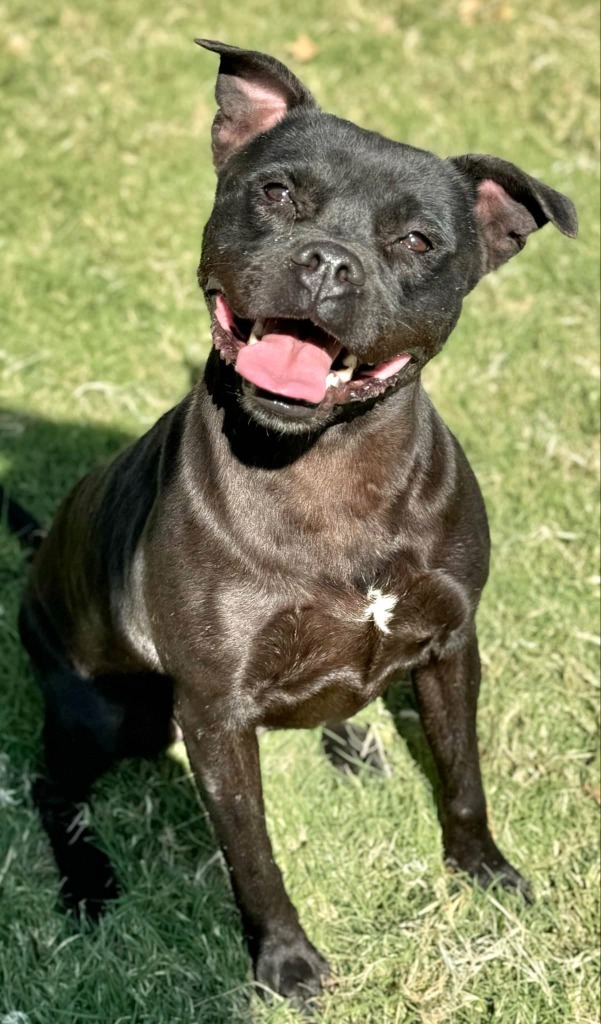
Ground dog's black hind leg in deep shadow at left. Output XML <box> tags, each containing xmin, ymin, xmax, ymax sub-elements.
<box><xmin>33</xmin><ymin>671</ymin><xmax>172</xmax><ymax>919</ymax></box>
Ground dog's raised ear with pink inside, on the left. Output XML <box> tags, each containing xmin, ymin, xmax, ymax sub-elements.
<box><xmin>195</xmin><ymin>39</ymin><xmax>316</xmax><ymax>170</ymax></box>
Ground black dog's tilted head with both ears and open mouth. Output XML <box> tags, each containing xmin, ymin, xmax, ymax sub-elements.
<box><xmin>197</xmin><ymin>40</ymin><xmax>576</xmax><ymax>432</ymax></box>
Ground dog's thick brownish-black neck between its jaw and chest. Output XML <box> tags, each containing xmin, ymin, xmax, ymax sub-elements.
<box><xmin>187</xmin><ymin>352</ymin><xmax>435</xmax><ymax>580</ymax></box>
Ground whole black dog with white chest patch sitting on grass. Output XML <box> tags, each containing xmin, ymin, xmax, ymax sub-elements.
<box><xmin>9</xmin><ymin>40</ymin><xmax>576</xmax><ymax>1007</ymax></box>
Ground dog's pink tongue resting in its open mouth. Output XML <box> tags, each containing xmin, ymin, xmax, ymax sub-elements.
<box><xmin>235</xmin><ymin>334</ymin><xmax>332</xmax><ymax>404</ymax></box>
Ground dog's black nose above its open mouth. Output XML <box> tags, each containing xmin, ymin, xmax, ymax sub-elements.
<box><xmin>292</xmin><ymin>242</ymin><xmax>366</xmax><ymax>300</ymax></box>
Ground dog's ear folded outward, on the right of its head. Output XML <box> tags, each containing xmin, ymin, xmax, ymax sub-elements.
<box><xmin>450</xmin><ymin>154</ymin><xmax>578</xmax><ymax>273</ymax></box>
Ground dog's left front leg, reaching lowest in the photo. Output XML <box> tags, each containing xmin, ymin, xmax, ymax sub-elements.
<box><xmin>178</xmin><ymin>701</ymin><xmax>329</xmax><ymax>1009</ymax></box>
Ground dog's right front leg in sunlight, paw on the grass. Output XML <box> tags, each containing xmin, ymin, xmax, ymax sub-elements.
<box><xmin>413</xmin><ymin>633</ymin><xmax>528</xmax><ymax>896</ymax></box>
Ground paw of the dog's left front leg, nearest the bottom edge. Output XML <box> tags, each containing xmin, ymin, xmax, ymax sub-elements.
<box><xmin>255</xmin><ymin>932</ymin><xmax>330</xmax><ymax>1016</ymax></box>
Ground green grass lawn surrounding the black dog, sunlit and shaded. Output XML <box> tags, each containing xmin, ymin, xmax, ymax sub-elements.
<box><xmin>0</xmin><ymin>0</ymin><xmax>599</xmax><ymax>1024</ymax></box>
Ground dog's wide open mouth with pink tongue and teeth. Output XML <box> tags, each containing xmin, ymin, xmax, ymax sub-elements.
<box><xmin>212</xmin><ymin>294</ymin><xmax>415</xmax><ymax>406</ymax></box>
